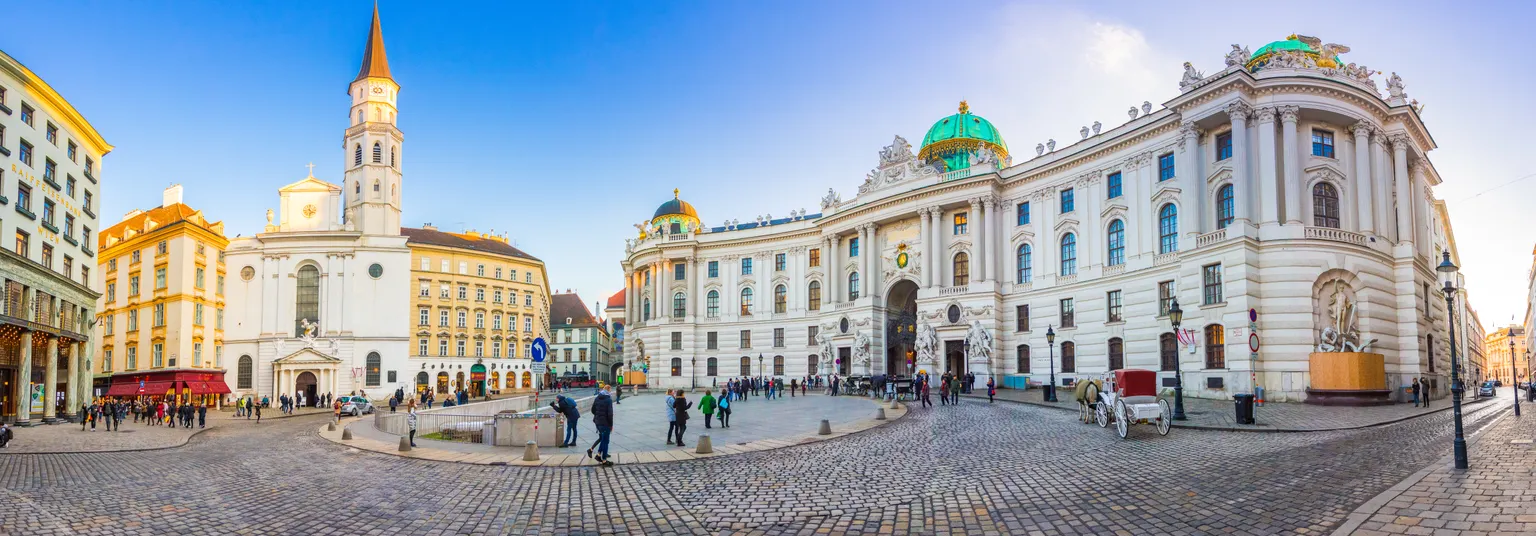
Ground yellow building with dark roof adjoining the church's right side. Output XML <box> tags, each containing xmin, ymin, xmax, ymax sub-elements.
<box><xmin>401</xmin><ymin>224</ymin><xmax>550</xmax><ymax>396</ymax></box>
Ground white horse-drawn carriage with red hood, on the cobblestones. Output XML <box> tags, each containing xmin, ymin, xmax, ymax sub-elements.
<box><xmin>1078</xmin><ymin>369</ymin><xmax>1174</xmax><ymax>439</ymax></box>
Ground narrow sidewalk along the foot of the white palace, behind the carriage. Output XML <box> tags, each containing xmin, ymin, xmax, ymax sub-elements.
<box><xmin>964</xmin><ymin>387</ymin><xmax>1492</xmax><ymax>432</ymax></box>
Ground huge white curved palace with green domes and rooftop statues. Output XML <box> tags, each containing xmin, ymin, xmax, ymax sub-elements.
<box><xmin>617</xmin><ymin>35</ymin><xmax>1459</xmax><ymax>401</ymax></box>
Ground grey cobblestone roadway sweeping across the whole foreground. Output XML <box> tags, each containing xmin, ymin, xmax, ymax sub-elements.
<box><xmin>0</xmin><ymin>388</ymin><xmax>1504</xmax><ymax>534</ymax></box>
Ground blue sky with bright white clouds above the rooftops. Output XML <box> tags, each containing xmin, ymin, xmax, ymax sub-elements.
<box><xmin>0</xmin><ymin>2</ymin><xmax>1536</xmax><ymax>330</ymax></box>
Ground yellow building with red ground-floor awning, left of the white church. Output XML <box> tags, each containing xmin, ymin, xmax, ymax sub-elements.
<box><xmin>94</xmin><ymin>184</ymin><xmax>230</xmax><ymax>404</ymax></box>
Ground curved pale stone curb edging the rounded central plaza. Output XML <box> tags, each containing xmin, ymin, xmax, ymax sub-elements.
<box><xmin>316</xmin><ymin>402</ymin><xmax>912</xmax><ymax>468</ymax></box>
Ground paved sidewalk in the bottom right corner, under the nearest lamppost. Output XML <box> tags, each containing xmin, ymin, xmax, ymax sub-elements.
<box><xmin>1335</xmin><ymin>412</ymin><xmax>1536</xmax><ymax>536</ymax></box>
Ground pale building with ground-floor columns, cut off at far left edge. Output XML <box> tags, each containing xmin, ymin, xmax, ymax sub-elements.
<box><xmin>0</xmin><ymin>47</ymin><xmax>112</xmax><ymax>425</ymax></box>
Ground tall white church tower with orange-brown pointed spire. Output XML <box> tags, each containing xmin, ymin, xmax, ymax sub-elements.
<box><xmin>343</xmin><ymin>5</ymin><xmax>404</xmax><ymax>235</ymax></box>
